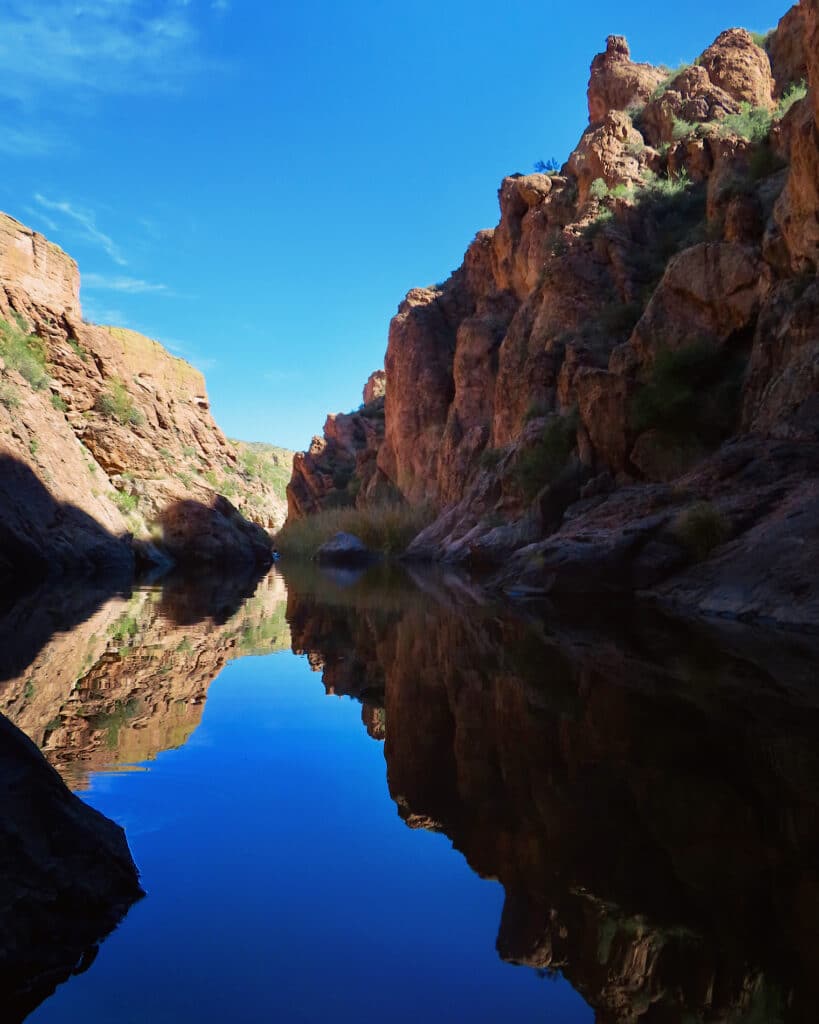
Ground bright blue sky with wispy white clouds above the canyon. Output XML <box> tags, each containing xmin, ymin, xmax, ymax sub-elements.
<box><xmin>0</xmin><ymin>0</ymin><xmax>786</xmax><ymax>447</ymax></box>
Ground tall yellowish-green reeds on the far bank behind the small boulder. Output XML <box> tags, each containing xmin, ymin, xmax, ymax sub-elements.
<box><xmin>276</xmin><ymin>503</ymin><xmax>433</xmax><ymax>558</ymax></box>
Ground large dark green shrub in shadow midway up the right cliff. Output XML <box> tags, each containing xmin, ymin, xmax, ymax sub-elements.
<box><xmin>631</xmin><ymin>342</ymin><xmax>743</xmax><ymax>445</ymax></box>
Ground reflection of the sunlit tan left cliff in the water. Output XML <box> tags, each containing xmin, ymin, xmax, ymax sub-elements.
<box><xmin>0</xmin><ymin>574</ymin><xmax>290</xmax><ymax>788</ymax></box>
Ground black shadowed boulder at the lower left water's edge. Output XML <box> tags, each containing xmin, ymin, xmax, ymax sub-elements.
<box><xmin>0</xmin><ymin>716</ymin><xmax>143</xmax><ymax>1022</ymax></box>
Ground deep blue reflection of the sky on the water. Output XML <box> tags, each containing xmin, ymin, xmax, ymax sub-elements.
<box><xmin>30</xmin><ymin>653</ymin><xmax>592</xmax><ymax>1024</ymax></box>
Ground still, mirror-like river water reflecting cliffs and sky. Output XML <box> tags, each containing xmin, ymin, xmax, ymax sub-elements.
<box><xmin>0</xmin><ymin>567</ymin><xmax>819</xmax><ymax>1024</ymax></box>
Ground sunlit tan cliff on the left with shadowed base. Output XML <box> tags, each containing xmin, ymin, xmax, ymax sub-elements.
<box><xmin>0</xmin><ymin>215</ymin><xmax>284</xmax><ymax>571</ymax></box>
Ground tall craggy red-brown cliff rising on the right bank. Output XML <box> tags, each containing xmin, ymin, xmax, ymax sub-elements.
<box><xmin>290</xmin><ymin>0</ymin><xmax>819</xmax><ymax>626</ymax></box>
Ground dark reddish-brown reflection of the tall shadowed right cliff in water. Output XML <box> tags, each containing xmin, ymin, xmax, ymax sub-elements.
<box><xmin>289</xmin><ymin>581</ymin><xmax>819</xmax><ymax>1024</ymax></box>
